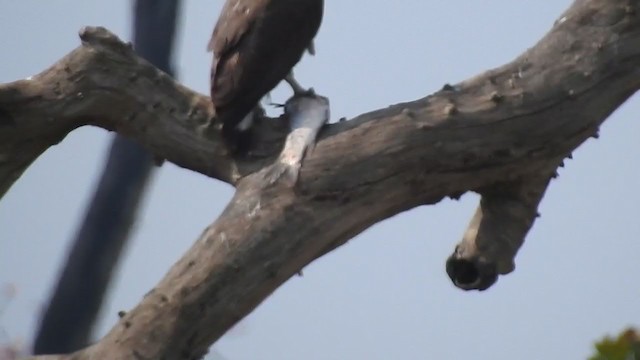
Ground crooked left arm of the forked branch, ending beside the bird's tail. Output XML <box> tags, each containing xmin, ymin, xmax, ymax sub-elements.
<box><xmin>0</xmin><ymin>28</ymin><xmax>232</xmax><ymax>198</ymax></box>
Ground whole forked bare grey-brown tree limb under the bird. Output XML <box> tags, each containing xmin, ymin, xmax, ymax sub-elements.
<box><xmin>0</xmin><ymin>0</ymin><xmax>640</xmax><ymax>359</ymax></box>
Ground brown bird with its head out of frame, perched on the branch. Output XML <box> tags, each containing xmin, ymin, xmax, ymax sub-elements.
<box><xmin>208</xmin><ymin>0</ymin><xmax>324</xmax><ymax>152</ymax></box>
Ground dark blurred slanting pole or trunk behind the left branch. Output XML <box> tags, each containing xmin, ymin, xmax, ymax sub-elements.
<box><xmin>33</xmin><ymin>0</ymin><xmax>180</xmax><ymax>354</ymax></box>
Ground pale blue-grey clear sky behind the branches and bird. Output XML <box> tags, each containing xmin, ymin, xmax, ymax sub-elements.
<box><xmin>0</xmin><ymin>0</ymin><xmax>640</xmax><ymax>360</ymax></box>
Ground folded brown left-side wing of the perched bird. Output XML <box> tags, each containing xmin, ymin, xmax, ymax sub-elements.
<box><xmin>207</xmin><ymin>0</ymin><xmax>268</xmax><ymax>105</ymax></box>
